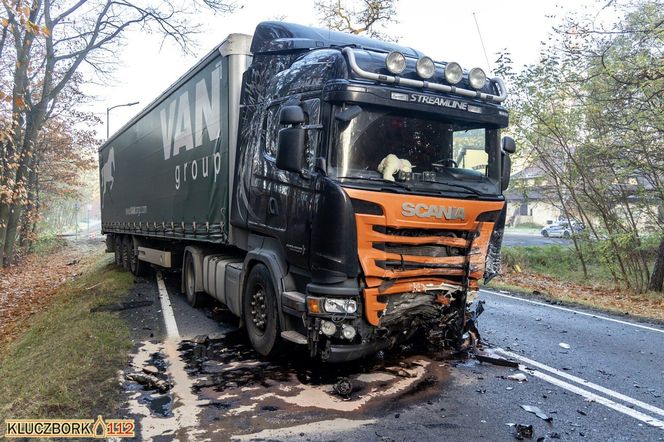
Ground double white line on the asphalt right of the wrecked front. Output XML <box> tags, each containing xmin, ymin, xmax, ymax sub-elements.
<box><xmin>496</xmin><ymin>348</ymin><xmax>664</xmax><ymax>430</ymax></box>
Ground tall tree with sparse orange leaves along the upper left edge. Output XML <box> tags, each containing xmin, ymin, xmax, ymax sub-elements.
<box><xmin>0</xmin><ymin>0</ymin><xmax>235</xmax><ymax>264</ymax></box>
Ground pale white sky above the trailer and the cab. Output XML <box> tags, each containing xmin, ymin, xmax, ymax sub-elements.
<box><xmin>87</xmin><ymin>0</ymin><xmax>594</xmax><ymax>138</ymax></box>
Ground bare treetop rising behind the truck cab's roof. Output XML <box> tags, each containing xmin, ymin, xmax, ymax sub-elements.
<box><xmin>314</xmin><ymin>0</ymin><xmax>398</xmax><ymax>41</ymax></box>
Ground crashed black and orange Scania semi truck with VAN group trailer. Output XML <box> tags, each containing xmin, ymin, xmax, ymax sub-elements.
<box><xmin>99</xmin><ymin>22</ymin><xmax>515</xmax><ymax>362</ymax></box>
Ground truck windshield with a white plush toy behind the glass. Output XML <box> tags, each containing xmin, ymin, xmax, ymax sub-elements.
<box><xmin>328</xmin><ymin>105</ymin><xmax>499</xmax><ymax>194</ymax></box>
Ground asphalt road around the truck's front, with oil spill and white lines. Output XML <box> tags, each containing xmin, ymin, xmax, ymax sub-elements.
<box><xmin>122</xmin><ymin>276</ymin><xmax>664</xmax><ymax>441</ymax></box>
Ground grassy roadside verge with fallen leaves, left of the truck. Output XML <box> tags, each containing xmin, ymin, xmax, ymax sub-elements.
<box><xmin>0</xmin><ymin>253</ymin><xmax>133</xmax><ymax>421</ymax></box>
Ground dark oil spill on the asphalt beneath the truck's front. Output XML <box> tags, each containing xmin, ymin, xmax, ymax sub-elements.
<box><xmin>179</xmin><ymin>331</ymin><xmax>450</xmax><ymax>437</ymax></box>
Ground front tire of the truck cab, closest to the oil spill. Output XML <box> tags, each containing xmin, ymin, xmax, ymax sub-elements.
<box><xmin>242</xmin><ymin>264</ymin><xmax>282</xmax><ymax>356</ymax></box>
